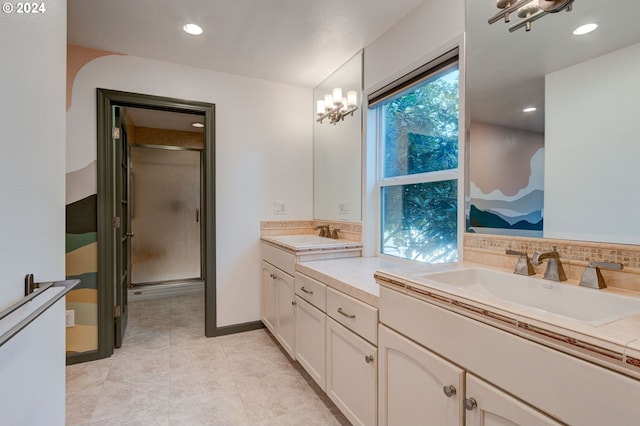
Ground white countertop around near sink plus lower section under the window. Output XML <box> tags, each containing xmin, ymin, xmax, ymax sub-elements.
<box><xmin>288</xmin><ymin>250</ymin><xmax>640</xmax><ymax>379</ymax></box>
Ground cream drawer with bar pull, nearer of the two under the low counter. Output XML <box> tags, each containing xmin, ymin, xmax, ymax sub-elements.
<box><xmin>327</xmin><ymin>288</ymin><xmax>378</xmax><ymax>345</ymax></box>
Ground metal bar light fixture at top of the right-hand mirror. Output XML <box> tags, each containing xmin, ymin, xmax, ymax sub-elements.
<box><xmin>489</xmin><ymin>0</ymin><xmax>574</xmax><ymax>33</ymax></box>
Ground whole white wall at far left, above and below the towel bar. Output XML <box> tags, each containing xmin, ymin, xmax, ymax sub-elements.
<box><xmin>0</xmin><ymin>0</ymin><xmax>67</xmax><ymax>425</ymax></box>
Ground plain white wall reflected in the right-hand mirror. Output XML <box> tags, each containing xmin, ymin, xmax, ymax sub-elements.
<box><xmin>544</xmin><ymin>44</ymin><xmax>640</xmax><ymax>244</ymax></box>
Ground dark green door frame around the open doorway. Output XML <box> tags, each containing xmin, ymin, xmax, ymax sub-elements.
<box><xmin>96</xmin><ymin>88</ymin><xmax>216</xmax><ymax>359</ymax></box>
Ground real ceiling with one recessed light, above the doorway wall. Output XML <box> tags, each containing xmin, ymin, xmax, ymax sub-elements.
<box><xmin>67</xmin><ymin>0</ymin><xmax>423</xmax><ymax>88</ymax></box>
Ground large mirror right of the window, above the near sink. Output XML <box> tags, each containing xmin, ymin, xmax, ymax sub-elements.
<box><xmin>466</xmin><ymin>0</ymin><xmax>640</xmax><ymax>244</ymax></box>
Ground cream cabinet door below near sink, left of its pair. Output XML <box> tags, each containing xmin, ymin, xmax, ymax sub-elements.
<box><xmin>378</xmin><ymin>325</ymin><xmax>464</xmax><ymax>426</ymax></box>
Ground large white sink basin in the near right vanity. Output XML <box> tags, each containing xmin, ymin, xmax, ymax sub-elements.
<box><xmin>420</xmin><ymin>268</ymin><xmax>640</xmax><ymax>326</ymax></box>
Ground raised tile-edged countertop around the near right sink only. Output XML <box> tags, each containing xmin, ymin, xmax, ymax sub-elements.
<box><xmin>376</xmin><ymin>262</ymin><xmax>640</xmax><ymax>379</ymax></box>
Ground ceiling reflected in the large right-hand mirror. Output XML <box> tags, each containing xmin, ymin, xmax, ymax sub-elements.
<box><xmin>466</xmin><ymin>0</ymin><xmax>640</xmax><ymax>133</ymax></box>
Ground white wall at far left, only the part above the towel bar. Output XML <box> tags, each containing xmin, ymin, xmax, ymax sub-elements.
<box><xmin>0</xmin><ymin>0</ymin><xmax>67</xmax><ymax>308</ymax></box>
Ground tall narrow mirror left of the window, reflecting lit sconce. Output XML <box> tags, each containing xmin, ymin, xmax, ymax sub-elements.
<box><xmin>313</xmin><ymin>52</ymin><xmax>363</xmax><ymax>222</ymax></box>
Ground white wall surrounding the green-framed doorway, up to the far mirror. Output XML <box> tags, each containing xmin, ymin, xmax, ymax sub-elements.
<box><xmin>67</xmin><ymin>55</ymin><xmax>313</xmax><ymax>327</ymax></box>
